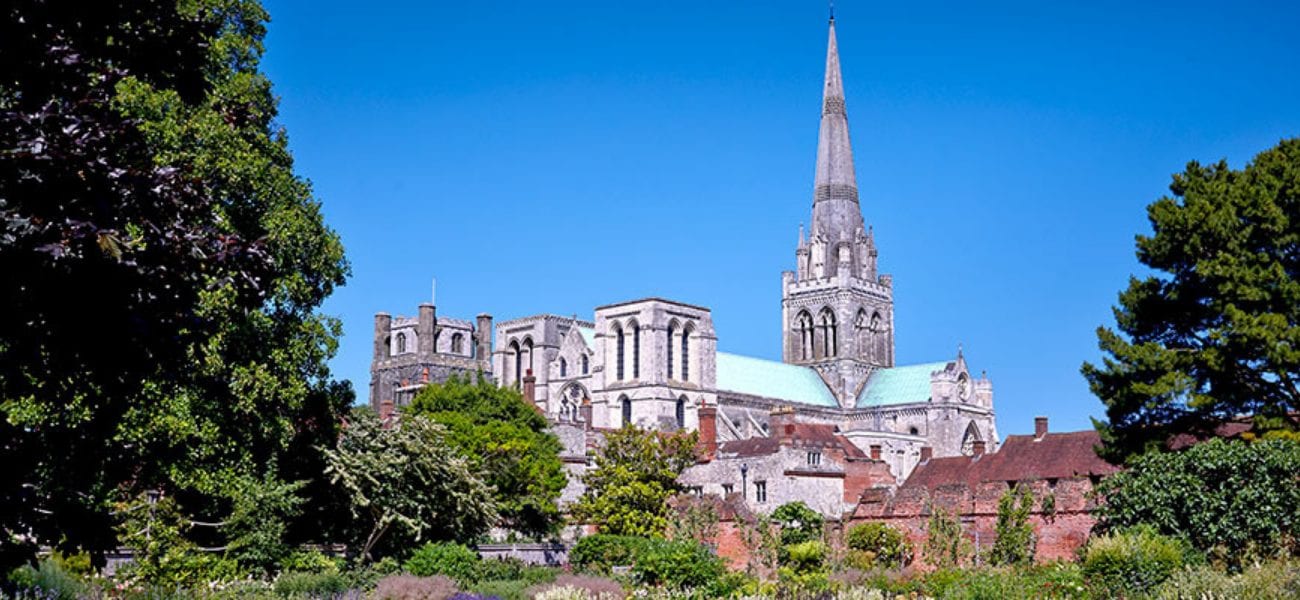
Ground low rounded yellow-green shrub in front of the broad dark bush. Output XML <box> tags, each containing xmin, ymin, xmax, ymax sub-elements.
<box><xmin>1082</xmin><ymin>526</ymin><xmax>1193</xmax><ymax>597</ymax></box>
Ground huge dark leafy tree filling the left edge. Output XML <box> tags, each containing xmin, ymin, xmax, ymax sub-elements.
<box><xmin>0</xmin><ymin>0</ymin><xmax>351</xmax><ymax>571</ymax></box>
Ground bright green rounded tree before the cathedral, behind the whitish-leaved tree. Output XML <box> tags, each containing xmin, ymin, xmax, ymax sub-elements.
<box><xmin>410</xmin><ymin>375</ymin><xmax>568</xmax><ymax>536</ymax></box>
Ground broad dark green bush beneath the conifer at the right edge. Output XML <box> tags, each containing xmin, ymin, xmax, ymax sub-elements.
<box><xmin>1097</xmin><ymin>439</ymin><xmax>1300</xmax><ymax>565</ymax></box>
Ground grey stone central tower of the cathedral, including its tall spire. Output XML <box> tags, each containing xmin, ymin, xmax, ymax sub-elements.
<box><xmin>781</xmin><ymin>18</ymin><xmax>894</xmax><ymax>408</ymax></box>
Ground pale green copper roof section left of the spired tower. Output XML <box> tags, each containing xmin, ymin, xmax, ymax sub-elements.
<box><xmin>718</xmin><ymin>352</ymin><xmax>837</xmax><ymax>406</ymax></box>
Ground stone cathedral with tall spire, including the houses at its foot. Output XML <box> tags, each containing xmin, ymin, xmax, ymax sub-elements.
<box><xmin>371</xmin><ymin>19</ymin><xmax>998</xmax><ymax>514</ymax></box>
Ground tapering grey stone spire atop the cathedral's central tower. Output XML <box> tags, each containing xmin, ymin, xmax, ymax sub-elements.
<box><xmin>813</xmin><ymin>20</ymin><xmax>862</xmax><ymax>245</ymax></box>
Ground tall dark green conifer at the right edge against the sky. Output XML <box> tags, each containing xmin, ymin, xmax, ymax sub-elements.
<box><xmin>1083</xmin><ymin>138</ymin><xmax>1300</xmax><ymax>462</ymax></box>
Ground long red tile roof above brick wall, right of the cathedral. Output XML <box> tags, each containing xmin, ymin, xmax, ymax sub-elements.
<box><xmin>904</xmin><ymin>431</ymin><xmax>1119</xmax><ymax>490</ymax></box>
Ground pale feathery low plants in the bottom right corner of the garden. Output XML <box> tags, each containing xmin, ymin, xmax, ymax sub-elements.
<box><xmin>1156</xmin><ymin>560</ymin><xmax>1300</xmax><ymax>600</ymax></box>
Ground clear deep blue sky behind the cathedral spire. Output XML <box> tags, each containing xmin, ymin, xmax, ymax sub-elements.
<box><xmin>264</xmin><ymin>0</ymin><xmax>1300</xmax><ymax>435</ymax></box>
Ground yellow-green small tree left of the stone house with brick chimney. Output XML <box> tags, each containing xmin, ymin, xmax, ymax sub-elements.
<box><xmin>572</xmin><ymin>425</ymin><xmax>698</xmax><ymax>536</ymax></box>
